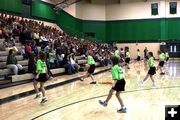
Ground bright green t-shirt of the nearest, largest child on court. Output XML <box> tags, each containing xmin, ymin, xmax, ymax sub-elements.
<box><xmin>112</xmin><ymin>65</ymin><xmax>124</xmax><ymax>80</ymax></box>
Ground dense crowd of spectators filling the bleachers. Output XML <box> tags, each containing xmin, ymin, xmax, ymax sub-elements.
<box><xmin>0</xmin><ymin>14</ymin><xmax>112</xmax><ymax>74</ymax></box>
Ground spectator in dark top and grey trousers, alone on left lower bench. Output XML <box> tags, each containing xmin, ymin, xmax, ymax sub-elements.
<box><xmin>6</xmin><ymin>49</ymin><xmax>23</xmax><ymax>75</ymax></box>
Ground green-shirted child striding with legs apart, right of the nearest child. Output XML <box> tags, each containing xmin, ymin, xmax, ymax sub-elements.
<box><xmin>140</xmin><ymin>52</ymin><xmax>156</xmax><ymax>88</ymax></box>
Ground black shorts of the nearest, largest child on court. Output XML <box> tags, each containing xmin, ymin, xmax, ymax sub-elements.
<box><xmin>112</xmin><ymin>79</ymin><xmax>126</xmax><ymax>92</ymax></box>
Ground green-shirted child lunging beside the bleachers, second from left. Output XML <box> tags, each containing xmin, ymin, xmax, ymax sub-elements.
<box><xmin>80</xmin><ymin>50</ymin><xmax>96</xmax><ymax>84</ymax></box>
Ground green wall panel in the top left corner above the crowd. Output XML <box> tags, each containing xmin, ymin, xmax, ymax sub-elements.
<box><xmin>0</xmin><ymin>0</ymin><xmax>22</xmax><ymax>13</ymax></box>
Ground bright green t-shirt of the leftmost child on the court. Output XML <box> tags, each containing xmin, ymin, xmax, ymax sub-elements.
<box><xmin>36</xmin><ymin>59</ymin><xmax>47</xmax><ymax>73</ymax></box>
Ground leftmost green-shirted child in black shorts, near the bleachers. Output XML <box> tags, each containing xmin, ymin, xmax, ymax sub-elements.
<box><xmin>34</xmin><ymin>52</ymin><xmax>48</xmax><ymax>103</ymax></box>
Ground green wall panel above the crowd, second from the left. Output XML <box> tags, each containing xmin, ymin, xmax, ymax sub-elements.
<box><xmin>31</xmin><ymin>1</ymin><xmax>56</xmax><ymax>21</ymax></box>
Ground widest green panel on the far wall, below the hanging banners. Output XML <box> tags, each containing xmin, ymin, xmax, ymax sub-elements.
<box><xmin>106</xmin><ymin>20</ymin><xmax>160</xmax><ymax>42</ymax></box>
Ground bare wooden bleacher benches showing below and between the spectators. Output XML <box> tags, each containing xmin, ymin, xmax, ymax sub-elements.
<box><xmin>0</xmin><ymin>39</ymin><xmax>100</xmax><ymax>85</ymax></box>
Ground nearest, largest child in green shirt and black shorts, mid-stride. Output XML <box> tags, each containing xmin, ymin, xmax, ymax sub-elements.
<box><xmin>99</xmin><ymin>56</ymin><xmax>126</xmax><ymax>113</ymax></box>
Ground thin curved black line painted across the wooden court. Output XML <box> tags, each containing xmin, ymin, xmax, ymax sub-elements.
<box><xmin>31</xmin><ymin>86</ymin><xmax>180</xmax><ymax>120</ymax></box>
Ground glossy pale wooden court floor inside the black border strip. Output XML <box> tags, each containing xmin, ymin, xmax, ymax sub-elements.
<box><xmin>0</xmin><ymin>61</ymin><xmax>180</xmax><ymax>120</ymax></box>
